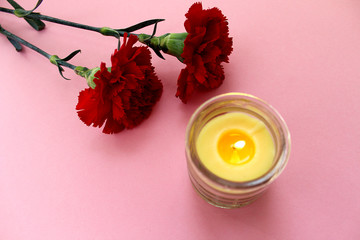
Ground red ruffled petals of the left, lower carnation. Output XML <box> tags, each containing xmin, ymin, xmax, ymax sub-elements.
<box><xmin>76</xmin><ymin>34</ymin><xmax>163</xmax><ymax>134</ymax></box>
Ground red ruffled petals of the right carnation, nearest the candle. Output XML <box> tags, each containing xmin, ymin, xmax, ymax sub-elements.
<box><xmin>176</xmin><ymin>3</ymin><xmax>232</xmax><ymax>103</ymax></box>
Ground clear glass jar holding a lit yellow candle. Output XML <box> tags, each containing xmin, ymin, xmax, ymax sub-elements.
<box><xmin>186</xmin><ymin>93</ymin><xmax>290</xmax><ymax>208</ymax></box>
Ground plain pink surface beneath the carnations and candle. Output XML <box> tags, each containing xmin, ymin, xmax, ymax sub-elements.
<box><xmin>0</xmin><ymin>0</ymin><xmax>360</xmax><ymax>240</ymax></box>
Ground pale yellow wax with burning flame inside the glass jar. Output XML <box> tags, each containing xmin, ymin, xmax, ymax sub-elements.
<box><xmin>196</xmin><ymin>112</ymin><xmax>275</xmax><ymax>182</ymax></box>
